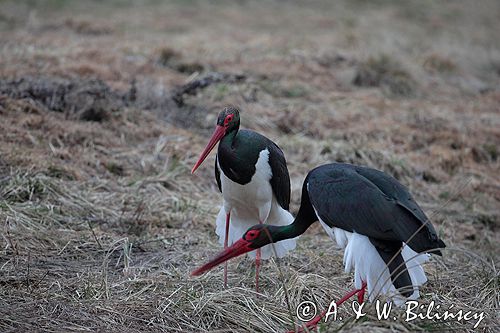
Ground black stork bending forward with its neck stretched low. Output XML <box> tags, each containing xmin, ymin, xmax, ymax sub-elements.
<box><xmin>191</xmin><ymin>163</ymin><xmax>445</xmax><ymax>327</ymax></box>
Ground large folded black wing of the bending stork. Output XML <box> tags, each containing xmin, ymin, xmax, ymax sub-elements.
<box><xmin>307</xmin><ymin>163</ymin><xmax>445</xmax><ymax>252</ymax></box>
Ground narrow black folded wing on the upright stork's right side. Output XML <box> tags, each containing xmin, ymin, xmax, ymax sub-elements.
<box><xmin>267</xmin><ymin>142</ymin><xmax>290</xmax><ymax>210</ymax></box>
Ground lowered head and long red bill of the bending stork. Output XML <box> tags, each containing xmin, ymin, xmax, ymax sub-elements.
<box><xmin>191</xmin><ymin>224</ymin><xmax>273</xmax><ymax>276</ymax></box>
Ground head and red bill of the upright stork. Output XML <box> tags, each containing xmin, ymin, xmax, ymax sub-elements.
<box><xmin>191</xmin><ymin>106</ymin><xmax>240</xmax><ymax>173</ymax></box>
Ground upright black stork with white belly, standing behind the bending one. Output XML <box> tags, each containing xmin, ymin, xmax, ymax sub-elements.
<box><xmin>191</xmin><ymin>107</ymin><xmax>295</xmax><ymax>290</ymax></box>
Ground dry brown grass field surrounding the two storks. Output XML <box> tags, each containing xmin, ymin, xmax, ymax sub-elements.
<box><xmin>0</xmin><ymin>0</ymin><xmax>500</xmax><ymax>332</ymax></box>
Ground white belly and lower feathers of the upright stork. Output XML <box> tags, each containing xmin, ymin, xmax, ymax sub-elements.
<box><xmin>216</xmin><ymin>149</ymin><xmax>295</xmax><ymax>259</ymax></box>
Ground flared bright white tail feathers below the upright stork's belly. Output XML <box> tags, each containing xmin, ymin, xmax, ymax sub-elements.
<box><xmin>215</xmin><ymin>206</ymin><xmax>296</xmax><ymax>259</ymax></box>
